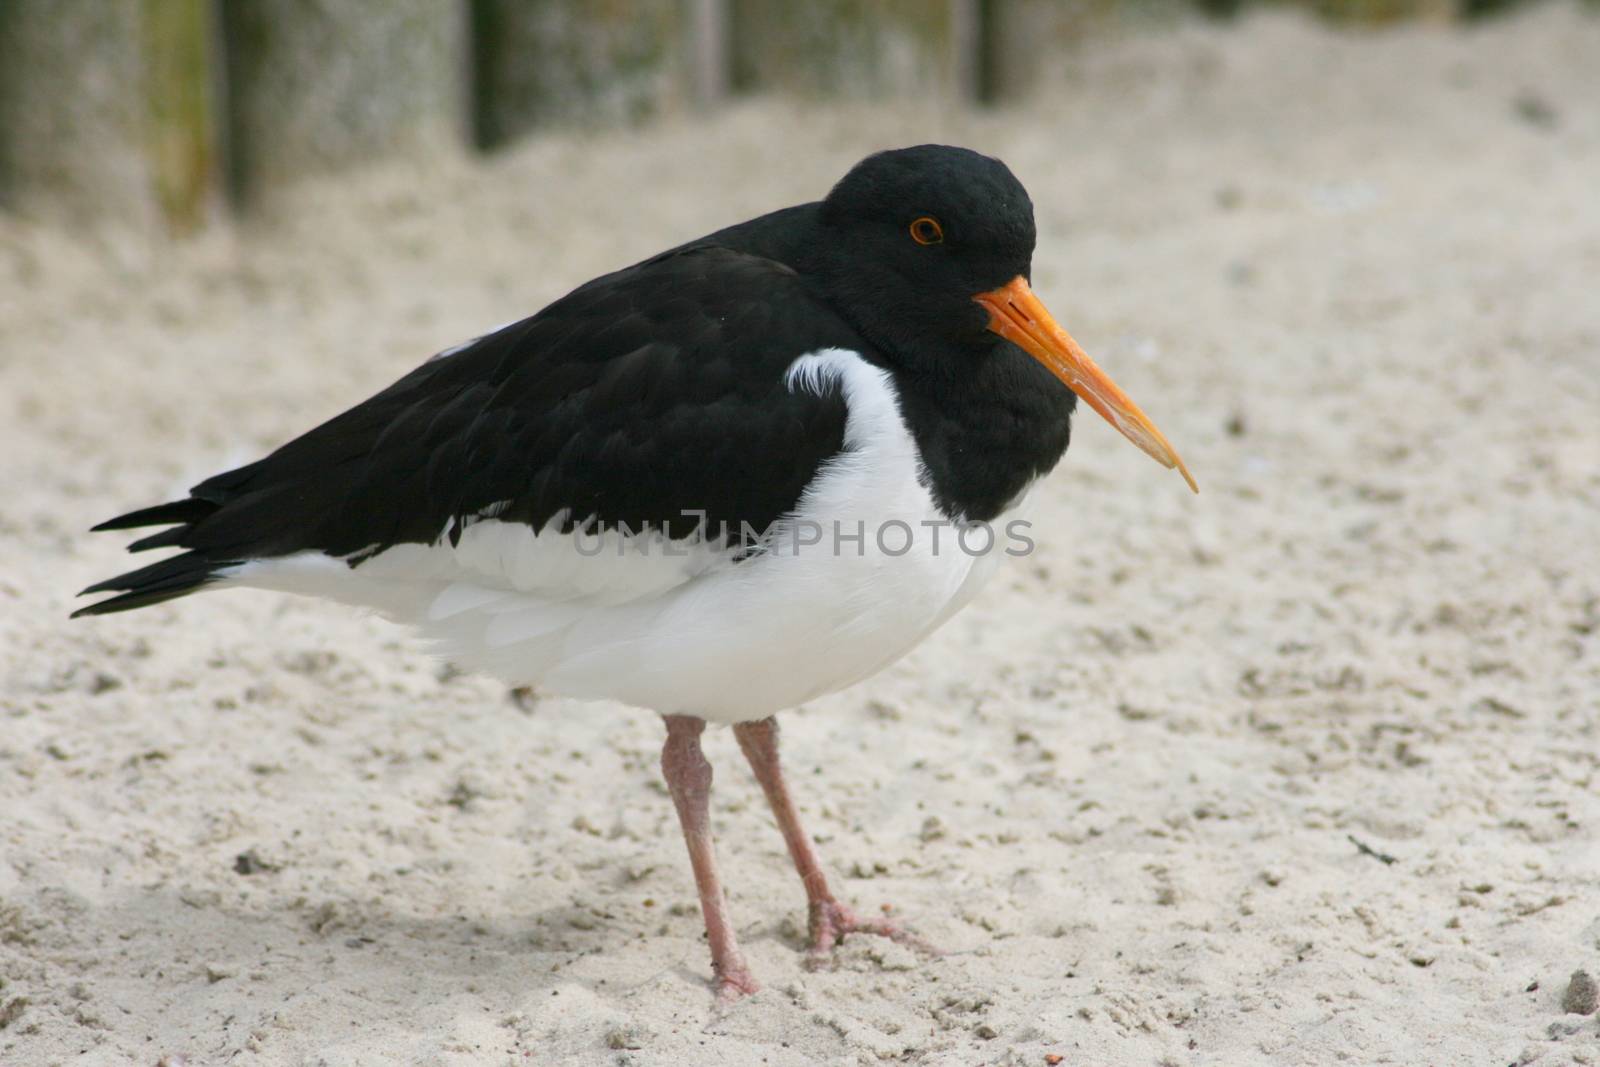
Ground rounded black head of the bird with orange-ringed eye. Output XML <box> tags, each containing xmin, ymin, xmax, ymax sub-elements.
<box><xmin>818</xmin><ymin>144</ymin><xmax>1035</xmax><ymax>360</ymax></box>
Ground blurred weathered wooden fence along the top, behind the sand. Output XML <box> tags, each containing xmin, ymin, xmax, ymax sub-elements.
<box><xmin>0</xmin><ymin>0</ymin><xmax>1600</xmax><ymax>234</ymax></box>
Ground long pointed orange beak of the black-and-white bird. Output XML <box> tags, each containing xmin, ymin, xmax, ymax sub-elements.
<box><xmin>973</xmin><ymin>275</ymin><xmax>1200</xmax><ymax>493</ymax></box>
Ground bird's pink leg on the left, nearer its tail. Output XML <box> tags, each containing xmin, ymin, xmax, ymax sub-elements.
<box><xmin>661</xmin><ymin>715</ymin><xmax>760</xmax><ymax>1000</ymax></box>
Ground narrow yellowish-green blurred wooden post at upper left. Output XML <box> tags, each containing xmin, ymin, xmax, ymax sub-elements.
<box><xmin>141</xmin><ymin>0</ymin><xmax>219</xmax><ymax>234</ymax></box>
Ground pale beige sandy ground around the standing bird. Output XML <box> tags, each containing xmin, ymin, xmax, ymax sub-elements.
<box><xmin>0</xmin><ymin>6</ymin><xmax>1600</xmax><ymax>1067</ymax></box>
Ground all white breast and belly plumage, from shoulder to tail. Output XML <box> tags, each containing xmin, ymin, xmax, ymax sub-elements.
<box><xmin>222</xmin><ymin>349</ymin><xmax>1021</xmax><ymax>721</ymax></box>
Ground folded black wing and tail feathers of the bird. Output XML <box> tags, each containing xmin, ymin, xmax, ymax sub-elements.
<box><xmin>75</xmin><ymin>248</ymin><xmax>866</xmax><ymax>614</ymax></box>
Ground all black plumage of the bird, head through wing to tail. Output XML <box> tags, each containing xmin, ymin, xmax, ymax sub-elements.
<box><xmin>75</xmin><ymin>146</ymin><xmax>1075</xmax><ymax>614</ymax></box>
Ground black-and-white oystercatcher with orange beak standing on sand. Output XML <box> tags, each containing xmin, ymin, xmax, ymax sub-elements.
<box><xmin>74</xmin><ymin>144</ymin><xmax>1198</xmax><ymax>1001</ymax></box>
